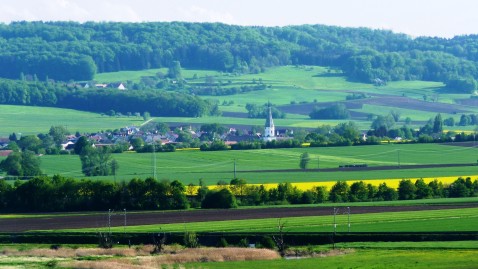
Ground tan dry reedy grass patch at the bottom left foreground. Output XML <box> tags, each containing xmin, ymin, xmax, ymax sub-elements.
<box><xmin>0</xmin><ymin>245</ymin><xmax>280</xmax><ymax>269</ymax></box>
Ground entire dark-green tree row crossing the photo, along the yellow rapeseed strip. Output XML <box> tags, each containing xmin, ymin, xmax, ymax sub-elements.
<box><xmin>0</xmin><ymin>176</ymin><xmax>478</xmax><ymax>212</ymax></box>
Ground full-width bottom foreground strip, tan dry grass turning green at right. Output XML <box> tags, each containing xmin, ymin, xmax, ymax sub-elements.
<box><xmin>0</xmin><ymin>241</ymin><xmax>478</xmax><ymax>269</ymax></box>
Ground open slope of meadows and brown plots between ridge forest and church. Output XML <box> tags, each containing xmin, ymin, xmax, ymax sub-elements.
<box><xmin>95</xmin><ymin>66</ymin><xmax>478</xmax><ymax>130</ymax></box>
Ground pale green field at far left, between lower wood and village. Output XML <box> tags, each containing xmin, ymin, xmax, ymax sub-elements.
<box><xmin>0</xmin><ymin>105</ymin><xmax>143</xmax><ymax>137</ymax></box>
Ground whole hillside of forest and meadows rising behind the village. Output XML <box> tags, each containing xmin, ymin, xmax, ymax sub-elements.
<box><xmin>0</xmin><ymin>22</ymin><xmax>478</xmax><ymax>133</ymax></box>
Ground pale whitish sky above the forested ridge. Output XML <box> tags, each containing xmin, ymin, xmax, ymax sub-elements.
<box><xmin>0</xmin><ymin>0</ymin><xmax>478</xmax><ymax>38</ymax></box>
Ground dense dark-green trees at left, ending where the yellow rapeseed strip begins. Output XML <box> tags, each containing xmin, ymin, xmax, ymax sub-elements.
<box><xmin>0</xmin><ymin>176</ymin><xmax>189</xmax><ymax>212</ymax></box>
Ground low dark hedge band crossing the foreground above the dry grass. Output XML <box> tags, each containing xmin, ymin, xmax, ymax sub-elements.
<box><xmin>0</xmin><ymin>232</ymin><xmax>478</xmax><ymax>247</ymax></box>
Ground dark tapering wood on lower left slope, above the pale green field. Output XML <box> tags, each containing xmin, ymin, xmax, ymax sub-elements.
<box><xmin>0</xmin><ymin>79</ymin><xmax>219</xmax><ymax>117</ymax></box>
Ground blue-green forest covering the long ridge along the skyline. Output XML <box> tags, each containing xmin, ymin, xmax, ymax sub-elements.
<box><xmin>0</xmin><ymin>22</ymin><xmax>478</xmax><ymax>86</ymax></box>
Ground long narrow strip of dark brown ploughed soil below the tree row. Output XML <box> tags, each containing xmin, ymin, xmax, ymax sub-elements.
<box><xmin>0</xmin><ymin>203</ymin><xmax>478</xmax><ymax>232</ymax></box>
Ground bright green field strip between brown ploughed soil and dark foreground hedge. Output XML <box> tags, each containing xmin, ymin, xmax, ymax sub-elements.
<box><xmin>60</xmin><ymin>206</ymin><xmax>478</xmax><ymax>233</ymax></box>
